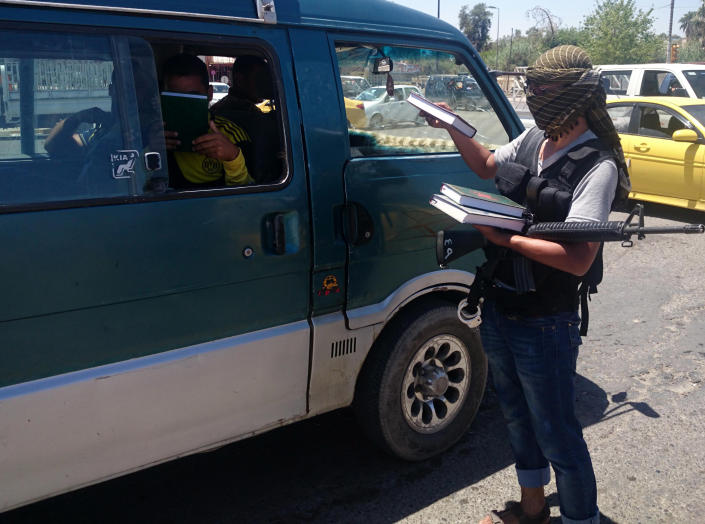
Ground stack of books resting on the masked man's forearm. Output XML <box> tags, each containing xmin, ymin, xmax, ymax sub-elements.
<box><xmin>430</xmin><ymin>184</ymin><xmax>533</xmax><ymax>232</ymax></box>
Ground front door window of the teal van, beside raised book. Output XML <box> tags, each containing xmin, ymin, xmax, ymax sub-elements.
<box><xmin>336</xmin><ymin>43</ymin><xmax>509</xmax><ymax>157</ymax></box>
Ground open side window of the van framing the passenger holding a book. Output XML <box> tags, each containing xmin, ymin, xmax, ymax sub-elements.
<box><xmin>154</xmin><ymin>50</ymin><xmax>286</xmax><ymax>192</ymax></box>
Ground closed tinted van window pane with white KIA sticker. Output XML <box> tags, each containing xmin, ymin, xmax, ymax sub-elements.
<box><xmin>0</xmin><ymin>31</ymin><xmax>165</xmax><ymax>206</ymax></box>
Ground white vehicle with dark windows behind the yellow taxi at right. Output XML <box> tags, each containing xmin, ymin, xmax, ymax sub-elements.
<box><xmin>595</xmin><ymin>64</ymin><xmax>705</xmax><ymax>98</ymax></box>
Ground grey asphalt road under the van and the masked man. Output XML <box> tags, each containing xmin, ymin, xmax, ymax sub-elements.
<box><xmin>0</xmin><ymin>205</ymin><xmax>705</xmax><ymax>524</ymax></box>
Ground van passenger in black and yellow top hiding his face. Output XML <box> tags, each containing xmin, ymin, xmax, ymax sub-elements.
<box><xmin>163</xmin><ymin>54</ymin><xmax>254</xmax><ymax>189</ymax></box>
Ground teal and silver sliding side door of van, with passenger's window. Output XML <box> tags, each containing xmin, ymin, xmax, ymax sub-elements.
<box><xmin>0</xmin><ymin>16</ymin><xmax>312</xmax><ymax>510</ymax></box>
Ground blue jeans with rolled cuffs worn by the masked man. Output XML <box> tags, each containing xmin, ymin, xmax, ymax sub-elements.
<box><xmin>480</xmin><ymin>301</ymin><xmax>599</xmax><ymax>524</ymax></box>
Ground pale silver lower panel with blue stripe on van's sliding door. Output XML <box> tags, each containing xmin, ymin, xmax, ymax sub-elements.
<box><xmin>0</xmin><ymin>322</ymin><xmax>309</xmax><ymax>511</ymax></box>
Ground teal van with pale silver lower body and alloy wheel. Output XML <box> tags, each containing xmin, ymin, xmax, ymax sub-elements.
<box><xmin>0</xmin><ymin>0</ymin><xmax>522</xmax><ymax>510</ymax></box>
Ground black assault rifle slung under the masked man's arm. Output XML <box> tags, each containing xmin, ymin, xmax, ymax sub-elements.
<box><xmin>436</xmin><ymin>204</ymin><xmax>705</xmax><ymax>328</ymax></box>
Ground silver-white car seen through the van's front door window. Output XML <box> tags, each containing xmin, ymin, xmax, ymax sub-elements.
<box><xmin>355</xmin><ymin>85</ymin><xmax>426</xmax><ymax>128</ymax></box>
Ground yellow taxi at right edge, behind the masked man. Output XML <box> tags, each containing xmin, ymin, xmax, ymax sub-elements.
<box><xmin>607</xmin><ymin>96</ymin><xmax>705</xmax><ymax>211</ymax></box>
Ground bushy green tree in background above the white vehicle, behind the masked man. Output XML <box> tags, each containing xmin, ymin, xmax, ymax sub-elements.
<box><xmin>583</xmin><ymin>0</ymin><xmax>665</xmax><ymax>64</ymax></box>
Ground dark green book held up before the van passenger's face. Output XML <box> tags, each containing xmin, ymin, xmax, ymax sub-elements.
<box><xmin>161</xmin><ymin>91</ymin><xmax>210</xmax><ymax>151</ymax></box>
